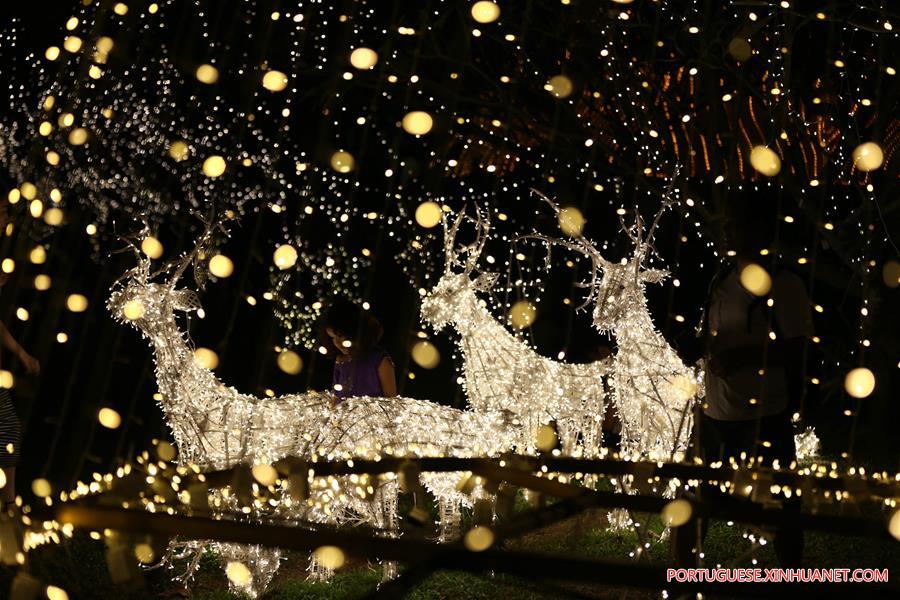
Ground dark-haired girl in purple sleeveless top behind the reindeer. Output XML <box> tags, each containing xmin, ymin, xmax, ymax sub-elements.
<box><xmin>324</xmin><ymin>300</ymin><xmax>397</xmax><ymax>399</ymax></box>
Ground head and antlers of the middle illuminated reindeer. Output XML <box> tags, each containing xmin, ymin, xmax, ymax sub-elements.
<box><xmin>421</xmin><ymin>208</ymin><xmax>497</xmax><ymax>330</ymax></box>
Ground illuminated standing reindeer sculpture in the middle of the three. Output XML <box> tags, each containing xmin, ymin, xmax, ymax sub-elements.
<box><xmin>421</xmin><ymin>211</ymin><xmax>610</xmax><ymax>456</ymax></box>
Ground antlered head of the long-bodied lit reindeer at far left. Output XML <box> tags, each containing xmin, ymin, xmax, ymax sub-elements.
<box><xmin>107</xmin><ymin>229</ymin><xmax>210</xmax><ymax>335</ymax></box>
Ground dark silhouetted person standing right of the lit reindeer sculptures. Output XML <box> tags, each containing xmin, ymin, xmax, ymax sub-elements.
<box><xmin>673</xmin><ymin>196</ymin><xmax>812</xmax><ymax>567</ymax></box>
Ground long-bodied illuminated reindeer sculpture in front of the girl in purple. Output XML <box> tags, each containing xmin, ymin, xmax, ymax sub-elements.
<box><xmin>108</xmin><ymin>228</ymin><xmax>511</xmax><ymax>594</ymax></box>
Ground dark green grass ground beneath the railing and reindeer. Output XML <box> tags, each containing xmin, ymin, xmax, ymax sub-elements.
<box><xmin>0</xmin><ymin>502</ymin><xmax>900</xmax><ymax>600</ymax></box>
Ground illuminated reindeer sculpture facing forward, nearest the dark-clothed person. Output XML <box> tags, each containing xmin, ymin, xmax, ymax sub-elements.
<box><xmin>528</xmin><ymin>192</ymin><xmax>703</xmax><ymax>460</ymax></box>
